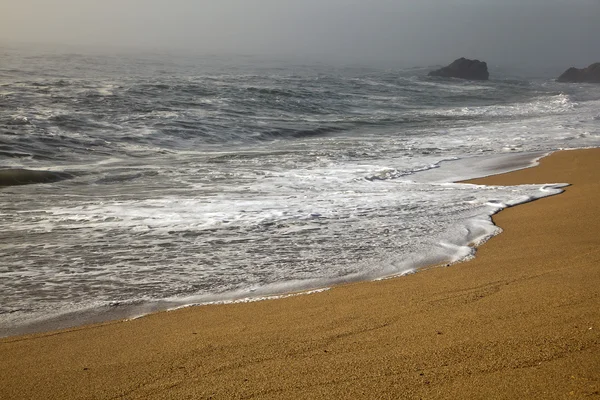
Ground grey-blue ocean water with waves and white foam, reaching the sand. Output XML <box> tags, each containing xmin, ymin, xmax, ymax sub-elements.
<box><xmin>0</xmin><ymin>48</ymin><xmax>600</xmax><ymax>336</ymax></box>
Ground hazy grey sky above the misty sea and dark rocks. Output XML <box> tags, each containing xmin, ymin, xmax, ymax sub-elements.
<box><xmin>0</xmin><ymin>0</ymin><xmax>600</xmax><ymax>66</ymax></box>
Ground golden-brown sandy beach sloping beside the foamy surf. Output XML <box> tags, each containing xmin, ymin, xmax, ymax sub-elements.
<box><xmin>0</xmin><ymin>149</ymin><xmax>600</xmax><ymax>399</ymax></box>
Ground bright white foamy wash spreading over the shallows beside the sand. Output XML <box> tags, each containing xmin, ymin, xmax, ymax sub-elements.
<box><xmin>0</xmin><ymin>165</ymin><xmax>572</xmax><ymax>340</ymax></box>
